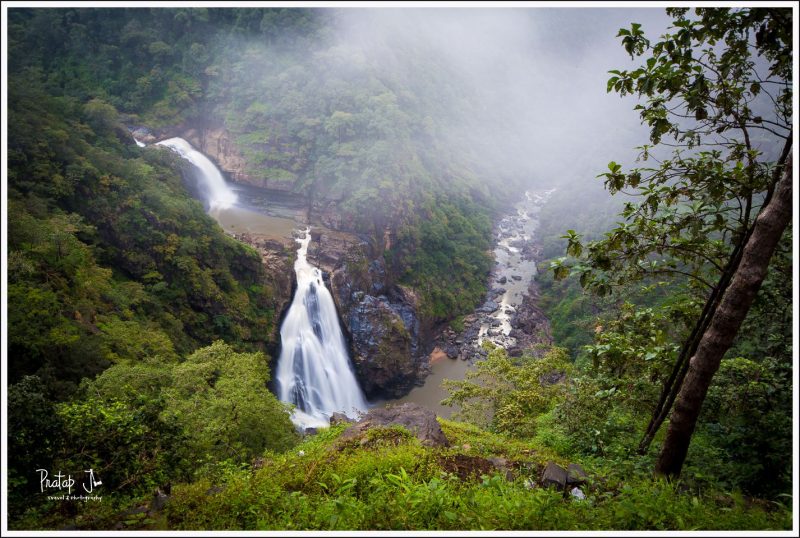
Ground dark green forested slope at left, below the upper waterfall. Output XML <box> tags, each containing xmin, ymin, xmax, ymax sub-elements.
<box><xmin>8</xmin><ymin>71</ymin><xmax>274</xmax><ymax>398</ymax></box>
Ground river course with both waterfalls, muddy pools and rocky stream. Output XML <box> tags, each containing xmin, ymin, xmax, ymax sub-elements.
<box><xmin>145</xmin><ymin>130</ymin><xmax>552</xmax><ymax>422</ymax></box>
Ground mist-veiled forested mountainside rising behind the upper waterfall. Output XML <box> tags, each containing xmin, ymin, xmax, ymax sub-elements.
<box><xmin>4</xmin><ymin>9</ymin><xmax>506</xmax><ymax>323</ymax></box>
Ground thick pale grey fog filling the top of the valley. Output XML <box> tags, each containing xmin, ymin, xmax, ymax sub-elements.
<box><xmin>322</xmin><ymin>8</ymin><xmax>670</xmax><ymax>191</ymax></box>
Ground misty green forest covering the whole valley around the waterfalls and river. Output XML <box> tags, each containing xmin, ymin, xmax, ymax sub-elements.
<box><xmin>3</xmin><ymin>6</ymin><xmax>798</xmax><ymax>533</ymax></box>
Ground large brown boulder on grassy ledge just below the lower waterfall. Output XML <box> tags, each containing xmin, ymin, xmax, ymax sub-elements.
<box><xmin>341</xmin><ymin>402</ymin><xmax>449</xmax><ymax>446</ymax></box>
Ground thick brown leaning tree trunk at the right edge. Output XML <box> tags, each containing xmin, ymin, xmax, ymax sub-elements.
<box><xmin>656</xmin><ymin>150</ymin><xmax>793</xmax><ymax>477</ymax></box>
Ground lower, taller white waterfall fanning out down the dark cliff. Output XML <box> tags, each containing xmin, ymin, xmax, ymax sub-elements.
<box><xmin>275</xmin><ymin>228</ymin><xmax>367</xmax><ymax>426</ymax></box>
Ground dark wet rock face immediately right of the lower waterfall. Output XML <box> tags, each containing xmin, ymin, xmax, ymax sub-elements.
<box><xmin>308</xmin><ymin>230</ymin><xmax>424</xmax><ymax>398</ymax></box>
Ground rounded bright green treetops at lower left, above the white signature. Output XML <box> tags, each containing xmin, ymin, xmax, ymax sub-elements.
<box><xmin>9</xmin><ymin>341</ymin><xmax>297</xmax><ymax>520</ymax></box>
